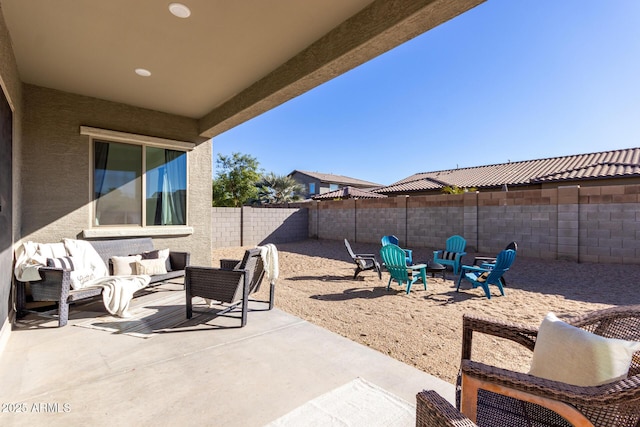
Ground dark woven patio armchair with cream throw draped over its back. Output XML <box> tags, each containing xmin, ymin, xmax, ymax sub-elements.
<box><xmin>185</xmin><ymin>249</ymin><xmax>275</xmax><ymax>327</ymax></box>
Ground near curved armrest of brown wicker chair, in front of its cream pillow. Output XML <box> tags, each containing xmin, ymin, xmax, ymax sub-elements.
<box><xmin>460</xmin><ymin>360</ymin><xmax>640</xmax><ymax>407</ymax></box>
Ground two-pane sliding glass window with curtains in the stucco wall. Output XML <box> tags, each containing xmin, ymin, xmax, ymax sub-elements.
<box><xmin>94</xmin><ymin>141</ymin><xmax>187</xmax><ymax>227</ymax></box>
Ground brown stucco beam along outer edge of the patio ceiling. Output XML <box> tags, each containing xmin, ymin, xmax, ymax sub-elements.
<box><xmin>199</xmin><ymin>0</ymin><xmax>486</xmax><ymax>138</ymax></box>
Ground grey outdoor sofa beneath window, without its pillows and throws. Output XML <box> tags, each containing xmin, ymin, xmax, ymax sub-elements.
<box><xmin>16</xmin><ymin>237</ymin><xmax>190</xmax><ymax>326</ymax></box>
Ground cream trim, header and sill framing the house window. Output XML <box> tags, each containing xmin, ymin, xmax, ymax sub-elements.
<box><xmin>80</xmin><ymin>126</ymin><xmax>191</xmax><ymax>238</ymax></box>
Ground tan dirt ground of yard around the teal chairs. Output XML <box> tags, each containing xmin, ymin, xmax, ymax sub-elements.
<box><xmin>213</xmin><ymin>240</ymin><xmax>640</xmax><ymax>383</ymax></box>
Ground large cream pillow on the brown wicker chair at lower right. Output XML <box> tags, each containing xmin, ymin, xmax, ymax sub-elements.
<box><xmin>529</xmin><ymin>313</ymin><xmax>640</xmax><ymax>386</ymax></box>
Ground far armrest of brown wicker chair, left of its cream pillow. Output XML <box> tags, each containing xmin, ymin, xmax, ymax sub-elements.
<box><xmin>462</xmin><ymin>314</ymin><xmax>538</xmax><ymax>360</ymax></box>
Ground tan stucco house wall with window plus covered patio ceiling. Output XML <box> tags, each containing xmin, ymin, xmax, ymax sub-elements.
<box><xmin>0</xmin><ymin>0</ymin><xmax>483</xmax><ymax>352</ymax></box>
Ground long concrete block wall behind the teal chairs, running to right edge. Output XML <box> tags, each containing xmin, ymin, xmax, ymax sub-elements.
<box><xmin>309</xmin><ymin>185</ymin><xmax>640</xmax><ymax>264</ymax></box>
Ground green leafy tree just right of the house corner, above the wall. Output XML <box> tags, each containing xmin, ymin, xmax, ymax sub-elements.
<box><xmin>212</xmin><ymin>153</ymin><xmax>260</xmax><ymax>207</ymax></box>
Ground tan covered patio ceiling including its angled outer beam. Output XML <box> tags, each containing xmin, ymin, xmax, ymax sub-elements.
<box><xmin>0</xmin><ymin>0</ymin><xmax>484</xmax><ymax>138</ymax></box>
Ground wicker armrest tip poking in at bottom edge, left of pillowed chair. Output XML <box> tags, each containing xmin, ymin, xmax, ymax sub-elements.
<box><xmin>416</xmin><ymin>390</ymin><xmax>476</xmax><ymax>427</ymax></box>
